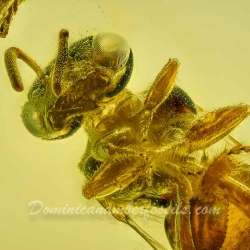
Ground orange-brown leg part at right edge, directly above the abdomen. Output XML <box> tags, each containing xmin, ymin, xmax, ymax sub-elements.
<box><xmin>203</xmin><ymin>145</ymin><xmax>250</xmax><ymax>218</ymax></box>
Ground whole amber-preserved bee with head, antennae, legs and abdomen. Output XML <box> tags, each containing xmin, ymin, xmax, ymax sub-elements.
<box><xmin>5</xmin><ymin>30</ymin><xmax>250</xmax><ymax>250</ymax></box>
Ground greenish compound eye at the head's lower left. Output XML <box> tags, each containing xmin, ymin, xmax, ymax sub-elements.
<box><xmin>21</xmin><ymin>102</ymin><xmax>46</xmax><ymax>137</ymax></box>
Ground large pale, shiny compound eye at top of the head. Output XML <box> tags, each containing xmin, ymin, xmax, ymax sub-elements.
<box><xmin>92</xmin><ymin>33</ymin><xmax>130</xmax><ymax>70</ymax></box>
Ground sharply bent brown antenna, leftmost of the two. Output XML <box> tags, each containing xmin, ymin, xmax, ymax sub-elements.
<box><xmin>4</xmin><ymin>47</ymin><xmax>44</xmax><ymax>92</ymax></box>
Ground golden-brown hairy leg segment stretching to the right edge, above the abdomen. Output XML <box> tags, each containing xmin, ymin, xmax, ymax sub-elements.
<box><xmin>184</xmin><ymin>104</ymin><xmax>250</xmax><ymax>152</ymax></box>
